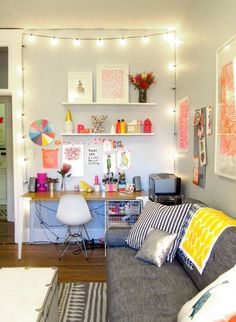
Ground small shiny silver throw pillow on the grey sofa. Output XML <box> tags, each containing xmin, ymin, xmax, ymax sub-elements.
<box><xmin>136</xmin><ymin>229</ymin><xmax>177</xmax><ymax>267</ymax></box>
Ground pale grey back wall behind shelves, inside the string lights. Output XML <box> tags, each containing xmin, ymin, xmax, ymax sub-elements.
<box><xmin>23</xmin><ymin>31</ymin><xmax>174</xmax><ymax>242</ymax></box>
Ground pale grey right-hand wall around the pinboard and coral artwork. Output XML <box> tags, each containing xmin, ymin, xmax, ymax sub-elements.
<box><xmin>177</xmin><ymin>0</ymin><xmax>236</xmax><ymax>217</ymax></box>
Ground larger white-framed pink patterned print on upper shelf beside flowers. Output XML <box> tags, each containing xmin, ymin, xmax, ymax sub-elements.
<box><xmin>97</xmin><ymin>65</ymin><xmax>129</xmax><ymax>104</ymax></box>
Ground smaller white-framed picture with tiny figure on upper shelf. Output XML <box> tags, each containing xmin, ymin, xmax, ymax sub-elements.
<box><xmin>68</xmin><ymin>72</ymin><xmax>93</xmax><ymax>103</ymax></box>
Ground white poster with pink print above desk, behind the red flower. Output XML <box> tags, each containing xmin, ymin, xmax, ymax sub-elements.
<box><xmin>62</xmin><ymin>143</ymin><xmax>84</xmax><ymax>177</ymax></box>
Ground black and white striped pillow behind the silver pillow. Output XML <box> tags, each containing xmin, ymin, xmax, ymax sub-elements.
<box><xmin>126</xmin><ymin>201</ymin><xmax>192</xmax><ymax>262</ymax></box>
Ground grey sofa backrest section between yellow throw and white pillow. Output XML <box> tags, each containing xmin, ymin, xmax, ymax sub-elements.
<box><xmin>178</xmin><ymin>227</ymin><xmax>236</xmax><ymax>290</ymax></box>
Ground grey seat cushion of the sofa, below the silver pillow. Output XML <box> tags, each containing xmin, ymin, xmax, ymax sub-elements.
<box><xmin>107</xmin><ymin>247</ymin><xmax>197</xmax><ymax>322</ymax></box>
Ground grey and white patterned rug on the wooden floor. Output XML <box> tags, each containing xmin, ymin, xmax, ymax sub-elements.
<box><xmin>59</xmin><ymin>283</ymin><xmax>107</xmax><ymax>322</ymax></box>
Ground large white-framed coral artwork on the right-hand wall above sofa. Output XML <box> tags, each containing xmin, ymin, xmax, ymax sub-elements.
<box><xmin>215</xmin><ymin>36</ymin><xmax>236</xmax><ymax>180</ymax></box>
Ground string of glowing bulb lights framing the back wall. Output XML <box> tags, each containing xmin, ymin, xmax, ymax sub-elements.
<box><xmin>17</xmin><ymin>30</ymin><xmax>177</xmax><ymax>185</ymax></box>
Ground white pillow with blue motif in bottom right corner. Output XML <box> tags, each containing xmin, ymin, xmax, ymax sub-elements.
<box><xmin>177</xmin><ymin>265</ymin><xmax>236</xmax><ymax>322</ymax></box>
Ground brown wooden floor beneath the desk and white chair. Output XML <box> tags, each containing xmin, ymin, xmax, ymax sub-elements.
<box><xmin>0</xmin><ymin>222</ymin><xmax>106</xmax><ymax>283</ymax></box>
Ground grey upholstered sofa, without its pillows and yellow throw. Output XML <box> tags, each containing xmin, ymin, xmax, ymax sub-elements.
<box><xmin>107</xmin><ymin>227</ymin><xmax>236</xmax><ymax>322</ymax></box>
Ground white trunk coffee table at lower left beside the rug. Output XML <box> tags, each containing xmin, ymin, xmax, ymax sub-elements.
<box><xmin>0</xmin><ymin>267</ymin><xmax>59</xmax><ymax>322</ymax></box>
